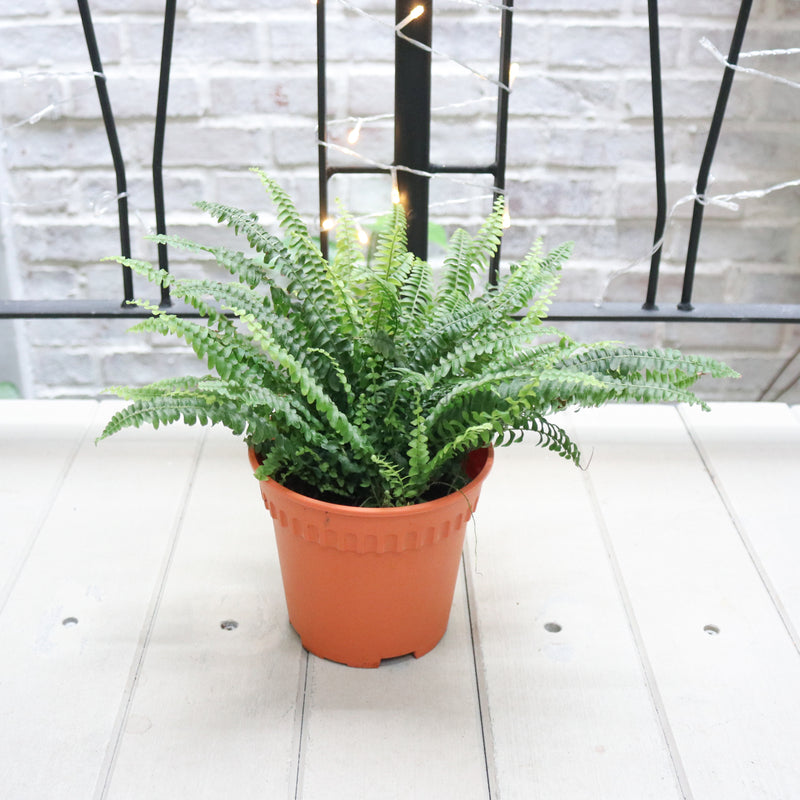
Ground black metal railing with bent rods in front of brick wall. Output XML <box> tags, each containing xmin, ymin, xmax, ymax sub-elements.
<box><xmin>0</xmin><ymin>0</ymin><xmax>800</xmax><ymax>323</ymax></box>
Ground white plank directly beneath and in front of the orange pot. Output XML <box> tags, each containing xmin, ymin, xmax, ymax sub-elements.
<box><xmin>298</xmin><ymin>574</ymin><xmax>488</xmax><ymax>800</ymax></box>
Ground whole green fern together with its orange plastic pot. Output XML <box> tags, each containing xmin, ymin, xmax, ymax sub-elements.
<box><xmin>100</xmin><ymin>170</ymin><xmax>735</xmax><ymax>666</ymax></box>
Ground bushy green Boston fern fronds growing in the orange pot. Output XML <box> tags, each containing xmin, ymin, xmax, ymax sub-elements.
<box><xmin>100</xmin><ymin>170</ymin><xmax>735</xmax><ymax>506</ymax></box>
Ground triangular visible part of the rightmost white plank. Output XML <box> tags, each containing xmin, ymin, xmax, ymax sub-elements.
<box><xmin>681</xmin><ymin>403</ymin><xmax>800</xmax><ymax>649</ymax></box>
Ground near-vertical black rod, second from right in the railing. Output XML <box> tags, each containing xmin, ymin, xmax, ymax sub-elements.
<box><xmin>642</xmin><ymin>0</ymin><xmax>667</xmax><ymax>311</ymax></box>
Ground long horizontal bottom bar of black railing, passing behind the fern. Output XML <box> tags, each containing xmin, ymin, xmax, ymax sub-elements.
<box><xmin>0</xmin><ymin>300</ymin><xmax>800</xmax><ymax>324</ymax></box>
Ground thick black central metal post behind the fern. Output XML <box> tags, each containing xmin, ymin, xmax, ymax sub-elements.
<box><xmin>394</xmin><ymin>0</ymin><xmax>433</xmax><ymax>259</ymax></box>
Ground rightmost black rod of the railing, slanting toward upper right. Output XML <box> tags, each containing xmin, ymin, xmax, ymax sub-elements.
<box><xmin>678</xmin><ymin>0</ymin><xmax>753</xmax><ymax>311</ymax></box>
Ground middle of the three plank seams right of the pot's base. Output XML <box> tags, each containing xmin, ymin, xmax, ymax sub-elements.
<box><xmin>583</xmin><ymin>471</ymin><xmax>694</xmax><ymax>800</ymax></box>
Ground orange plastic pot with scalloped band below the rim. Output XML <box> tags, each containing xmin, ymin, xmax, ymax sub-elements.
<box><xmin>250</xmin><ymin>448</ymin><xmax>494</xmax><ymax>667</ymax></box>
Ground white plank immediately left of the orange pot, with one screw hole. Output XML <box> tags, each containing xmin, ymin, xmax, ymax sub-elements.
<box><xmin>106</xmin><ymin>428</ymin><xmax>305</xmax><ymax>800</ymax></box>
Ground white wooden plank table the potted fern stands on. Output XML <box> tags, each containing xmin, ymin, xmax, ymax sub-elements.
<box><xmin>0</xmin><ymin>400</ymin><xmax>800</xmax><ymax>800</ymax></box>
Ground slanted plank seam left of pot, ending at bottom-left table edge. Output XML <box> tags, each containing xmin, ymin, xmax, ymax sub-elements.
<box><xmin>94</xmin><ymin>429</ymin><xmax>207</xmax><ymax>800</ymax></box>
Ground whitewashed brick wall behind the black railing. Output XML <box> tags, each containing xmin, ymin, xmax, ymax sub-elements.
<box><xmin>0</xmin><ymin>0</ymin><xmax>800</xmax><ymax>400</ymax></box>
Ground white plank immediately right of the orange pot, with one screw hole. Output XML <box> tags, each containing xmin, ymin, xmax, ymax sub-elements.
<box><xmin>468</xmin><ymin>434</ymin><xmax>681</xmax><ymax>800</ymax></box>
